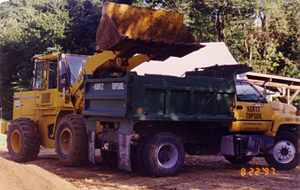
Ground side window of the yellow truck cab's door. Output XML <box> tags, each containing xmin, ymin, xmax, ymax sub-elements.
<box><xmin>236</xmin><ymin>81</ymin><xmax>263</xmax><ymax>102</ymax></box>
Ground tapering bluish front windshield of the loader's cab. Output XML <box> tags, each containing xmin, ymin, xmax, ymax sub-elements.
<box><xmin>66</xmin><ymin>55</ymin><xmax>89</xmax><ymax>86</ymax></box>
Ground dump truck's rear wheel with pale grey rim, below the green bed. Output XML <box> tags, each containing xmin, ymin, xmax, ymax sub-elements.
<box><xmin>143</xmin><ymin>132</ymin><xmax>184</xmax><ymax>177</ymax></box>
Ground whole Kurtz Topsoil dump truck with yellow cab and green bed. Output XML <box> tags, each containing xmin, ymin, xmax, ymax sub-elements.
<box><xmin>82</xmin><ymin>65</ymin><xmax>300</xmax><ymax>176</ymax></box>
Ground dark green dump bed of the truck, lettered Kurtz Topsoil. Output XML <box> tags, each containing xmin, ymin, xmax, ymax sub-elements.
<box><xmin>83</xmin><ymin>72</ymin><xmax>235</xmax><ymax>121</ymax></box>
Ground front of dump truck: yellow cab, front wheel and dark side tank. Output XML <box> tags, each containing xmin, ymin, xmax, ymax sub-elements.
<box><xmin>221</xmin><ymin>80</ymin><xmax>300</xmax><ymax>170</ymax></box>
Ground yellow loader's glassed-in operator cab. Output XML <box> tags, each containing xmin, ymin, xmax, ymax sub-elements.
<box><xmin>33</xmin><ymin>54</ymin><xmax>89</xmax><ymax>92</ymax></box>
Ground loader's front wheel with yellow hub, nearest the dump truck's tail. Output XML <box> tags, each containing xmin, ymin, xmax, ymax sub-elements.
<box><xmin>55</xmin><ymin>114</ymin><xmax>88</xmax><ymax>166</ymax></box>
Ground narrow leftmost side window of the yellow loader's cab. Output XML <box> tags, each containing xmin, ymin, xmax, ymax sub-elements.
<box><xmin>33</xmin><ymin>60</ymin><xmax>47</xmax><ymax>90</ymax></box>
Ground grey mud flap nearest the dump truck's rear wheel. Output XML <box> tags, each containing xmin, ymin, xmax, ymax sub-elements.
<box><xmin>118</xmin><ymin>134</ymin><xmax>133</xmax><ymax>171</ymax></box>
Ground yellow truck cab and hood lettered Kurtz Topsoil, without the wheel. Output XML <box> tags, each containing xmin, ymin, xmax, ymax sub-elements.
<box><xmin>230</xmin><ymin>81</ymin><xmax>299</xmax><ymax>136</ymax></box>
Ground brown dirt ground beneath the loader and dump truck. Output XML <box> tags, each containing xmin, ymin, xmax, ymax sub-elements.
<box><xmin>0</xmin><ymin>146</ymin><xmax>300</xmax><ymax>190</ymax></box>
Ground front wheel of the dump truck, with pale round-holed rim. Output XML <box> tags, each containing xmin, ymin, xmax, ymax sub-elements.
<box><xmin>265</xmin><ymin>132</ymin><xmax>300</xmax><ymax>170</ymax></box>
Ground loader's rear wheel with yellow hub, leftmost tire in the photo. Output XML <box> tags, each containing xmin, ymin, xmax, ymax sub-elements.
<box><xmin>7</xmin><ymin>118</ymin><xmax>40</xmax><ymax>162</ymax></box>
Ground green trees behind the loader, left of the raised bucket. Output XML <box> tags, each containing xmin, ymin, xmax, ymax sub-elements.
<box><xmin>0</xmin><ymin>0</ymin><xmax>101</xmax><ymax>119</ymax></box>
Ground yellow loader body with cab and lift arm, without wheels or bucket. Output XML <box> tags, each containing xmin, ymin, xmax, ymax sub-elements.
<box><xmin>13</xmin><ymin>51</ymin><xmax>149</xmax><ymax>147</ymax></box>
